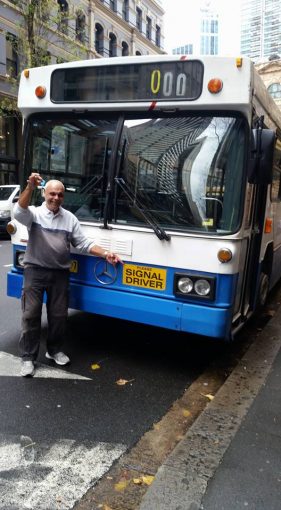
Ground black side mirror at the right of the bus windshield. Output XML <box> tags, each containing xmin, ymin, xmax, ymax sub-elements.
<box><xmin>248</xmin><ymin>128</ymin><xmax>276</xmax><ymax>184</ymax></box>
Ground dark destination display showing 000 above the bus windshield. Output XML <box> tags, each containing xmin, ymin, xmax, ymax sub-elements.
<box><xmin>51</xmin><ymin>60</ymin><xmax>204</xmax><ymax>103</ymax></box>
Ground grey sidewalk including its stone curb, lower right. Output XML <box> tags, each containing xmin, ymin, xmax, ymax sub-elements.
<box><xmin>139</xmin><ymin>307</ymin><xmax>281</xmax><ymax>510</ymax></box>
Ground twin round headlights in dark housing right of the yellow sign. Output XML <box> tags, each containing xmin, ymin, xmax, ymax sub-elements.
<box><xmin>174</xmin><ymin>273</ymin><xmax>216</xmax><ymax>300</ymax></box>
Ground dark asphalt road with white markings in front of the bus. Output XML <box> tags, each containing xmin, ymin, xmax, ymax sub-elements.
<box><xmin>0</xmin><ymin>240</ymin><xmax>230</xmax><ymax>510</ymax></box>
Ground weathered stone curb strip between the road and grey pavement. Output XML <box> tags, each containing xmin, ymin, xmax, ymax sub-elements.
<box><xmin>139</xmin><ymin>307</ymin><xmax>281</xmax><ymax>510</ymax></box>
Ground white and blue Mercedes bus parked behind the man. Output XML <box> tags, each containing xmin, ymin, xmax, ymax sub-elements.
<box><xmin>7</xmin><ymin>55</ymin><xmax>281</xmax><ymax>340</ymax></box>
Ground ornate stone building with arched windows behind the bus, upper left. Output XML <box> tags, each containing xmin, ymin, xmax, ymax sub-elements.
<box><xmin>0</xmin><ymin>0</ymin><xmax>164</xmax><ymax>184</ymax></box>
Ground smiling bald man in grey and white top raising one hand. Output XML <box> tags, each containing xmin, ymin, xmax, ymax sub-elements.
<box><xmin>14</xmin><ymin>173</ymin><xmax>122</xmax><ymax>377</ymax></box>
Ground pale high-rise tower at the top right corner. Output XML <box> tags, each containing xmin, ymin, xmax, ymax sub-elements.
<box><xmin>238</xmin><ymin>0</ymin><xmax>281</xmax><ymax>62</ymax></box>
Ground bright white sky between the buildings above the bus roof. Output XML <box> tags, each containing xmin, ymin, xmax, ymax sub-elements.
<box><xmin>161</xmin><ymin>0</ymin><xmax>241</xmax><ymax>55</ymax></box>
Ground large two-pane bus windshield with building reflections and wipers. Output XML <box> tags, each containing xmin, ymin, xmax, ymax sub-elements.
<box><xmin>25</xmin><ymin>112</ymin><xmax>247</xmax><ymax>234</ymax></box>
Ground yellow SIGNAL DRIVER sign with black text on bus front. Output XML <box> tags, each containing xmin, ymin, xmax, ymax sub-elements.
<box><xmin>122</xmin><ymin>264</ymin><xmax>167</xmax><ymax>290</ymax></box>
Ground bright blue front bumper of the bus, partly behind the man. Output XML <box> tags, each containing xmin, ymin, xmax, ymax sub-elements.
<box><xmin>7</xmin><ymin>272</ymin><xmax>231</xmax><ymax>339</ymax></box>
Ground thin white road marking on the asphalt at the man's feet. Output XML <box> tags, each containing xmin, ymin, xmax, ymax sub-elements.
<box><xmin>0</xmin><ymin>351</ymin><xmax>92</xmax><ymax>380</ymax></box>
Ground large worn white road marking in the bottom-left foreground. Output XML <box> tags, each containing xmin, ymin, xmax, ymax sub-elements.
<box><xmin>0</xmin><ymin>436</ymin><xmax>127</xmax><ymax>510</ymax></box>
